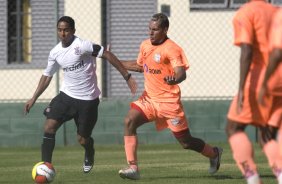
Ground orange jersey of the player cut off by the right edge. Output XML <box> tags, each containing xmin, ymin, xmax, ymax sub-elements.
<box><xmin>268</xmin><ymin>9</ymin><xmax>282</xmax><ymax>96</ymax></box>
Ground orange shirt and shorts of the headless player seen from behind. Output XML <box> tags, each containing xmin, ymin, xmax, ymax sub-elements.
<box><xmin>228</xmin><ymin>0</ymin><xmax>277</xmax><ymax>124</ymax></box>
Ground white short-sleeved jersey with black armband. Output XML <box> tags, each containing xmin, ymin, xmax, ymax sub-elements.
<box><xmin>43</xmin><ymin>36</ymin><xmax>104</xmax><ymax>100</ymax></box>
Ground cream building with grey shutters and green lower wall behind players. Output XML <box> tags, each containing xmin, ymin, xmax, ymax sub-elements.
<box><xmin>0</xmin><ymin>0</ymin><xmax>279</xmax><ymax>146</ymax></box>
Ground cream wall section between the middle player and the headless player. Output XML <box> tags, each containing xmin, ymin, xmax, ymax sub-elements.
<box><xmin>158</xmin><ymin>0</ymin><xmax>239</xmax><ymax>97</ymax></box>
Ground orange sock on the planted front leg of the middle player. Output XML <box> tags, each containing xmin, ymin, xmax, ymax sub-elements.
<box><xmin>124</xmin><ymin>136</ymin><xmax>138</xmax><ymax>169</ymax></box>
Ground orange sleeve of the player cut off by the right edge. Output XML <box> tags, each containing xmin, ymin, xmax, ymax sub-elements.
<box><xmin>269</xmin><ymin>9</ymin><xmax>282</xmax><ymax>50</ymax></box>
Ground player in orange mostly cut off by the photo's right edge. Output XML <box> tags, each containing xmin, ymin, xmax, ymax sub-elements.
<box><xmin>259</xmin><ymin>9</ymin><xmax>282</xmax><ymax>169</ymax></box>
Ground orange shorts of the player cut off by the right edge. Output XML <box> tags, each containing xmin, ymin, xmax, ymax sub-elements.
<box><xmin>268</xmin><ymin>96</ymin><xmax>282</xmax><ymax>127</ymax></box>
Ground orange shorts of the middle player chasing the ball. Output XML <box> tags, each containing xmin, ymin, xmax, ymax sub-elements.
<box><xmin>131</xmin><ymin>93</ymin><xmax>188</xmax><ymax>132</ymax></box>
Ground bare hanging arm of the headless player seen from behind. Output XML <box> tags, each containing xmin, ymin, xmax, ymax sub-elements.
<box><xmin>237</xmin><ymin>43</ymin><xmax>253</xmax><ymax>113</ymax></box>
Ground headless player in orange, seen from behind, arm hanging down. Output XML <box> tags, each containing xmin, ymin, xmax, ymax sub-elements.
<box><xmin>226</xmin><ymin>0</ymin><xmax>280</xmax><ymax>184</ymax></box>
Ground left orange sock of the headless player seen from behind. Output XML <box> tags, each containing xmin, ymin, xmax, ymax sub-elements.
<box><xmin>229</xmin><ymin>132</ymin><xmax>257</xmax><ymax>178</ymax></box>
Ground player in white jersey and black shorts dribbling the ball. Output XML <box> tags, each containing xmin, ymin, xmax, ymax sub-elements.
<box><xmin>24</xmin><ymin>16</ymin><xmax>137</xmax><ymax>173</ymax></box>
